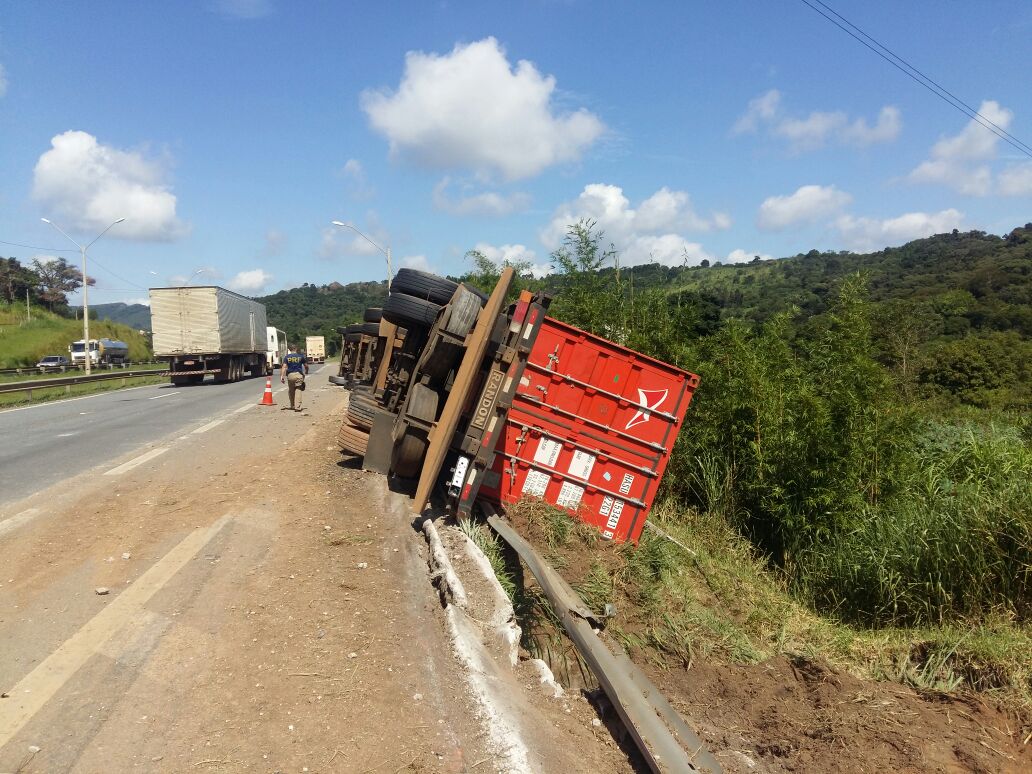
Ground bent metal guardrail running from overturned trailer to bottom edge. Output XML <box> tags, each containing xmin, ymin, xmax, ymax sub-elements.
<box><xmin>481</xmin><ymin>503</ymin><xmax>723</xmax><ymax>774</ymax></box>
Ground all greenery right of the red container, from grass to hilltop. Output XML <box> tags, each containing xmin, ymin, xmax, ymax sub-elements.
<box><xmin>468</xmin><ymin>222</ymin><xmax>1032</xmax><ymax>709</ymax></box>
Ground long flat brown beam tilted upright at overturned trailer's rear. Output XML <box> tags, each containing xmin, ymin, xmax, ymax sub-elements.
<box><xmin>414</xmin><ymin>266</ymin><xmax>514</xmax><ymax>513</ymax></box>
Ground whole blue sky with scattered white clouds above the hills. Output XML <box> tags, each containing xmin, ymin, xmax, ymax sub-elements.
<box><xmin>0</xmin><ymin>0</ymin><xmax>1032</xmax><ymax>302</ymax></box>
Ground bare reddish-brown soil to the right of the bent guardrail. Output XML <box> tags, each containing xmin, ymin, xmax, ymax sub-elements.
<box><xmin>512</xmin><ymin>511</ymin><xmax>1032</xmax><ymax>774</ymax></box>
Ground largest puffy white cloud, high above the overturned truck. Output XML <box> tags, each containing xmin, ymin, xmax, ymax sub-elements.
<box><xmin>361</xmin><ymin>37</ymin><xmax>605</xmax><ymax>180</ymax></box>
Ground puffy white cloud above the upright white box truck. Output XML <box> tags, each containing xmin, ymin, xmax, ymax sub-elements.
<box><xmin>32</xmin><ymin>131</ymin><xmax>189</xmax><ymax>241</ymax></box>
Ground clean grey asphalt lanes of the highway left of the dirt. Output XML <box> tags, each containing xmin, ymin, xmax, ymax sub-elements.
<box><xmin>0</xmin><ymin>364</ymin><xmax>332</xmax><ymax>507</ymax></box>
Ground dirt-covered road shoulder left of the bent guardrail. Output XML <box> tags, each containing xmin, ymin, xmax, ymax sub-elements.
<box><xmin>0</xmin><ymin>386</ymin><xmax>631</xmax><ymax>774</ymax></box>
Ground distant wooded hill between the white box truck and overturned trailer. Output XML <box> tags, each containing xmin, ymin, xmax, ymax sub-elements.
<box><xmin>256</xmin><ymin>282</ymin><xmax>387</xmax><ymax>354</ymax></box>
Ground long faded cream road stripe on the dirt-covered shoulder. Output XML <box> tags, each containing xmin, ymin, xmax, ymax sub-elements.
<box><xmin>0</xmin><ymin>516</ymin><xmax>229</xmax><ymax>747</ymax></box>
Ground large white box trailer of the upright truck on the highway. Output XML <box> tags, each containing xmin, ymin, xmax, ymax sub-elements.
<box><xmin>150</xmin><ymin>286</ymin><xmax>268</xmax><ymax>385</ymax></box>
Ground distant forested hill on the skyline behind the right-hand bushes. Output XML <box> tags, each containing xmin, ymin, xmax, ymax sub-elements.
<box><xmin>610</xmin><ymin>223</ymin><xmax>1032</xmax><ymax>337</ymax></box>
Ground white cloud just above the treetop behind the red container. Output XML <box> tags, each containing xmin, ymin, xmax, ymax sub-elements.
<box><xmin>541</xmin><ymin>183</ymin><xmax>731</xmax><ymax>266</ymax></box>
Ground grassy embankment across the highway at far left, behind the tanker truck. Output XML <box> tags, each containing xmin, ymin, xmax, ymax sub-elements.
<box><xmin>0</xmin><ymin>304</ymin><xmax>151</xmax><ymax>368</ymax></box>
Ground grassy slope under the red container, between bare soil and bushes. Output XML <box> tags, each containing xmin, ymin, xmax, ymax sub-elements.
<box><xmin>470</xmin><ymin>503</ymin><xmax>1032</xmax><ymax>723</ymax></box>
